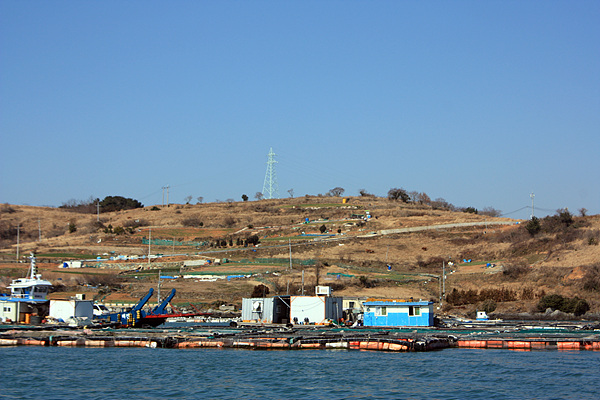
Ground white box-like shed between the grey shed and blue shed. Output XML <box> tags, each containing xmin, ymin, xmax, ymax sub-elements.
<box><xmin>290</xmin><ymin>296</ymin><xmax>343</xmax><ymax>324</ymax></box>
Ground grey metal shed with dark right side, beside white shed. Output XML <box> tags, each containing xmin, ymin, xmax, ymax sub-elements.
<box><xmin>242</xmin><ymin>296</ymin><xmax>290</xmax><ymax>324</ymax></box>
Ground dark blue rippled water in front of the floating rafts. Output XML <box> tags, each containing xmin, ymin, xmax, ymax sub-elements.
<box><xmin>0</xmin><ymin>347</ymin><xmax>600</xmax><ymax>400</ymax></box>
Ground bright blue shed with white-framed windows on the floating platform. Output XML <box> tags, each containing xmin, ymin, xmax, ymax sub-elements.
<box><xmin>363</xmin><ymin>300</ymin><xmax>433</xmax><ymax>326</ymax></box>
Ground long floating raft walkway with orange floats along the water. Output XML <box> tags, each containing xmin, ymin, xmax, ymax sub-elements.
<box><xmin>0</xmin><ymin>327</ymin><xmax>600</xmax><ymax>352</ymax></box>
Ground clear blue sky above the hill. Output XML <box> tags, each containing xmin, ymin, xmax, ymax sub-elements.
<box><xmin>0</xmin><ymin>1</ymin><xmax>600</xmax><ymax>218</ymax></box>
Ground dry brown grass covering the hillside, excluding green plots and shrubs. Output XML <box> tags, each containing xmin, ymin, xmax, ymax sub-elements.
<box><xmin>0</xmin><ymin>197</ymin><xmax>600</xmax><ymax>312</ymax></box>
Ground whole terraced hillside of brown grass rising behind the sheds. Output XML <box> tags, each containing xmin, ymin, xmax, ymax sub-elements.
<box><xmin>0</xmin><ymin>197</ymin><xmax>600</xmax><ymax>314</ymax></box>
